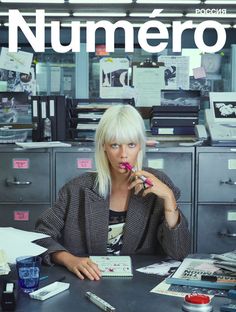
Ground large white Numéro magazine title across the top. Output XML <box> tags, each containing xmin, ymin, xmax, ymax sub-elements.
<box><xmin>8</xmin><ymin>9</ymin><xmax>226</xmax><ymax>53</ymax></box>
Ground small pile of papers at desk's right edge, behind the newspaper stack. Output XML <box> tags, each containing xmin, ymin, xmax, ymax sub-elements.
<box><xmin>212</xmin><ymin>250</ymin><xmax>236</xmax><ymax>272</ymax></box>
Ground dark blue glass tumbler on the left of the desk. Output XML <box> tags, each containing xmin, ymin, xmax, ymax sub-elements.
<box><xmin>16</xmin><ymin>256</ymin><xmax>41</xmax><ymax>293</ymax></box>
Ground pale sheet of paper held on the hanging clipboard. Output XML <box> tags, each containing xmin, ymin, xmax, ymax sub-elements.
<box><xmin>133</xmin><ymin>66</ymin><xmax>165</xmax><ymax>107</ymax></box>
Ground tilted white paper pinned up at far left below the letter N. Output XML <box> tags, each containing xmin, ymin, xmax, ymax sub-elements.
<box><xmin>0</xmin><ymin>47</ymin><xmax>33</xmax><ymax>74</ymax></box>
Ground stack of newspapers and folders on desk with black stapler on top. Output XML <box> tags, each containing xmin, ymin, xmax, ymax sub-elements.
<box><xmin>166</xmin><ymin>258</ymin><xmax>236</xmax><ymax>289</ymax></box>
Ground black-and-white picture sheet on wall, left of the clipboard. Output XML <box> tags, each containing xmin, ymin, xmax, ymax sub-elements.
<box><xmin>99</xmin><ymin>57</ymin><xmax>129</xmax><ymax>99</ymax></box>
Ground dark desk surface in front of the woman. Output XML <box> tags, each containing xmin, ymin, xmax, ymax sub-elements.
<box><xmin>0</xmin><ymin>256</ymin><xmax>228</xmax><ymax>312</ymax></box>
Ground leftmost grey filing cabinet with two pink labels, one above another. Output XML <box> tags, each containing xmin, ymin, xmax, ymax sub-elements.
<box><xmin>0</xmin><ymin>146</ymin><xmax>52</xmax><ymax>230</ymax></box>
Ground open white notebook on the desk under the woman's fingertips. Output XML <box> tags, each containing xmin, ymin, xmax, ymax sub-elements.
<box><xmin>90</xmin><ymin>256</ymin><xmax>133</xmax><ymax>277</ymax></box>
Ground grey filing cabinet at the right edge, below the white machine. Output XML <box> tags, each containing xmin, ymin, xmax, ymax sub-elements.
<box><xmin>196</xmin><ymin>147</ymin><xmax>236</xmax><ymax>253</ymax></box>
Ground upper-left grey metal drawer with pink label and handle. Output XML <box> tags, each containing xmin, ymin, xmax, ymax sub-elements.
<box><xmin>0</xmin><ymin>152</ymin><xmax>51</xmax><ymax>203</ymax></box>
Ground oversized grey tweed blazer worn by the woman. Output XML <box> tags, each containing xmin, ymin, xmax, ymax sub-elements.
<box><xmin>36</xmin><ymin>168</ymin><xmax>190</xmax><ymax>264</ymax></box>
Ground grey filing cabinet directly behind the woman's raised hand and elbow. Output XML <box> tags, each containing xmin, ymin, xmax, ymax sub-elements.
<box><xmin>144</xmin><ymin>143</ymin><xmax>195</xmax><ymax>250</ymax></box>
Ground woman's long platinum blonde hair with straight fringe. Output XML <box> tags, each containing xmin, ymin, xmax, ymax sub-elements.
<box><xmin>95</xmin><ymin>104</ymin><xmax>146</xmax><ymax>198</ymax></box>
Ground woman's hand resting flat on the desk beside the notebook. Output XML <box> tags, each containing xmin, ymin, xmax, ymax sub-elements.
<box><xmin>52</xmin><ymin>251</ymin><xmax>101</xmax><ymax>281</ymax></box>
